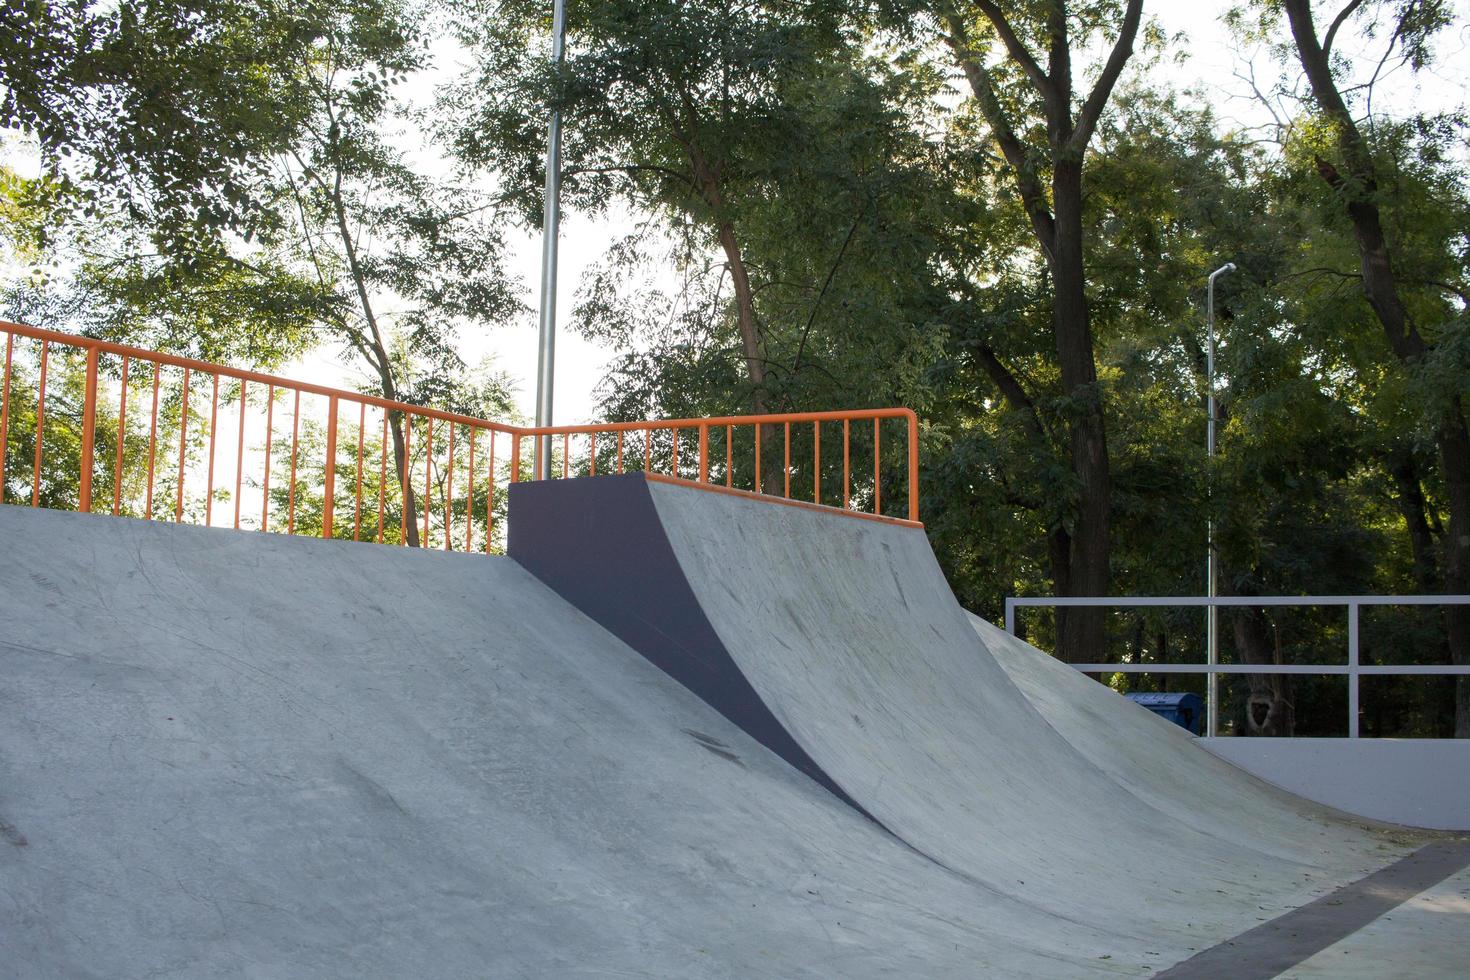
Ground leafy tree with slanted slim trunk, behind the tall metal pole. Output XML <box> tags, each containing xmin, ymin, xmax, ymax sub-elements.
<box><xmin>450</xmin><ymin>0</ymin><xmax>848</xmax><ymax>413</ymax></box>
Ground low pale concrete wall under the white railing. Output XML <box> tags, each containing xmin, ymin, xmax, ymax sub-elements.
<box><xmin>1200</xmin><ymin>738</ymin><xmax>1470</xmax><ymax>830</ymax></box>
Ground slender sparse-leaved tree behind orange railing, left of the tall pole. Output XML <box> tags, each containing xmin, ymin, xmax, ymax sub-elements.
<box><xmin>270</xmin><ymin>3</ymin><xmax>522</xmax><ymax>545</ymax></box>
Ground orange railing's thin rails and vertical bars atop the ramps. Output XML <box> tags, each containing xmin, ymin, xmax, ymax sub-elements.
<box><xmin>0</xmin><ymin>320</ymin><xmax>919</xmax><ymax>537</ymax></box>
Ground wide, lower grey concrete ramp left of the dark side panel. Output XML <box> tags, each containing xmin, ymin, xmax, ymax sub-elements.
<box><xmin>0</xmin><ymin>507</ymin><xmax>1176</xmax><ymax>979</ymax></box>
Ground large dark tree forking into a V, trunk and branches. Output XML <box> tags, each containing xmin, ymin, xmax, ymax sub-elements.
<box><xmin>911</xmin><ymin>0</ymin><xmax>1144</xmax><ymax>661</ymax></box>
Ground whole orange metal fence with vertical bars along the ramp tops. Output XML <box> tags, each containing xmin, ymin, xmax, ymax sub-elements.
<box><xmin>0</xmin><ymin>322</ymin><xmax>919</xmax><ymax>551</ymax></box>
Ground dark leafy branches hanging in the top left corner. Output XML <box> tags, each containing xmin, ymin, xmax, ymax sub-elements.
<box><xmin>0</xmin><ymin>0</ymin><xmax>326</xmax><ymax>244</ymax></box>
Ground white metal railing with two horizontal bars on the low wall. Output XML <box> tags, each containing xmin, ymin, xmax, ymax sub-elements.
<box><xmin>1005</xmin><ymin>595</ymin><xmax>1470</xmax><ymax>739</ymax></box>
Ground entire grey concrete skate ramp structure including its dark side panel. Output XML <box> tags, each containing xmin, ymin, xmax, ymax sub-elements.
<box><xmin>0</xmin><ymin>475</ymin><xmax>1470</xmax><ymax>977</ymax></box>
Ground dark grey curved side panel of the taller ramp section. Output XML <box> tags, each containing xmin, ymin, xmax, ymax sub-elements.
<box><xmin>506</xmin><ymin>473</ymin><xmax>870</xmax><ymax>817</ymax></box>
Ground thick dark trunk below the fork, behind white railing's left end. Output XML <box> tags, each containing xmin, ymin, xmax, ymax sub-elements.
<box><xmin>1051</xmin><ymin>157</ymin><xmax>1113</xmax><ymax>663</ymax></box>
